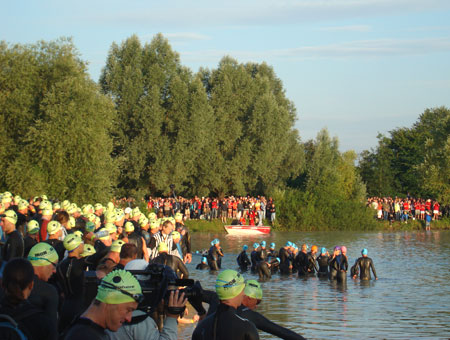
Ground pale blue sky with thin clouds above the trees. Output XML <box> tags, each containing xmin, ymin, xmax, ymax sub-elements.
<box><xmin>0</xmin><ymin>0</ymin><xmax>450</xmax><ymax>153</ymax></box>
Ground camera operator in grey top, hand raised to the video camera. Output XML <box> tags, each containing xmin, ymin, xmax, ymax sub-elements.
<box><xmin>107</xmin><ymin>260</ymin><xmax>186</xmax><ymax>340</ymax></box>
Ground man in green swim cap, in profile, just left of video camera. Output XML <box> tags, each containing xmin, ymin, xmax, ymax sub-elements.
<box><xmin>64</xmin><ymin>269</ymin><xmax>143</xmax><ymax>340</ymax></box>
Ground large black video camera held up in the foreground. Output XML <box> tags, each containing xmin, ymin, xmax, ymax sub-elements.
<box><xmin>84</xmin><ymin>263</ymin><xmax>204</xmax><ymax>314</ymax></box>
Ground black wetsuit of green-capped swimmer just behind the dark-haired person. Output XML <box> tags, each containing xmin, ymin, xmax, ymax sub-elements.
<box><xmin>28</xmin><ymin>275</ymin><xmax>59</xmax><ymax>334</ymax></box>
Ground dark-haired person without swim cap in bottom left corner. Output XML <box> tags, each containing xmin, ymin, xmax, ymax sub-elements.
<box><xmin>0</xmin><ymin>258</ymin><xmax>58</xmax><ymax>340</ymax></box>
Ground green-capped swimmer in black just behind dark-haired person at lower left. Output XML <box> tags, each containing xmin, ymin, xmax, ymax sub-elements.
<box><xmin>28</xmin><ymin>242</ymin><xmax>59</xmax><ymax>332</ymax></box>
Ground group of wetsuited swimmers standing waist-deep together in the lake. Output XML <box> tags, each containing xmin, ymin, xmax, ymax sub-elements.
<box><xmin>196</xmin><ymin>239</ymin><xmax>378</xmax><ymax>282</ymax></box>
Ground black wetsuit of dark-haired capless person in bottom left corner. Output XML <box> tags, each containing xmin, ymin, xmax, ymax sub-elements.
<box><xmin>0</xmin><ymin>298</ymin><xmax>58</xmax><ymax>340</ymax></box>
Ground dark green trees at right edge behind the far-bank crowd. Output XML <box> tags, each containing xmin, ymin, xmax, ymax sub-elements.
<box><xmin>359</xmin><ymin>107</ymin><xmax>450</xmax><ymax>204</ymax></box>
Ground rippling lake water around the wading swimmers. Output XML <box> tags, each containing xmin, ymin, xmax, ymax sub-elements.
<box><xmin>179</xmin><ymin>231</ymin><xmax>450</xmax><ymax>339</ymax></box>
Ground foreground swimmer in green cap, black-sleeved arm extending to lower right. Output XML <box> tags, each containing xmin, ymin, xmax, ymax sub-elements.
<box><xmin>237</xmin><ymin>280</ymin><xmax>305</xmax><ymax>340</ymax></box>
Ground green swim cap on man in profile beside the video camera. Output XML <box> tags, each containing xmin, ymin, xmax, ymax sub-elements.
<box><xmin>95</xmin><ymin>269</ymin><xmax>143</xmax><ymax>305</ymax></box>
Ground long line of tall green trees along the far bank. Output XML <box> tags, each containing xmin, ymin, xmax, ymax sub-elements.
<box><xmin>0</xmin><ymin>34</ymin><xmax>449</xmax><ymax>228</ymax></box>
